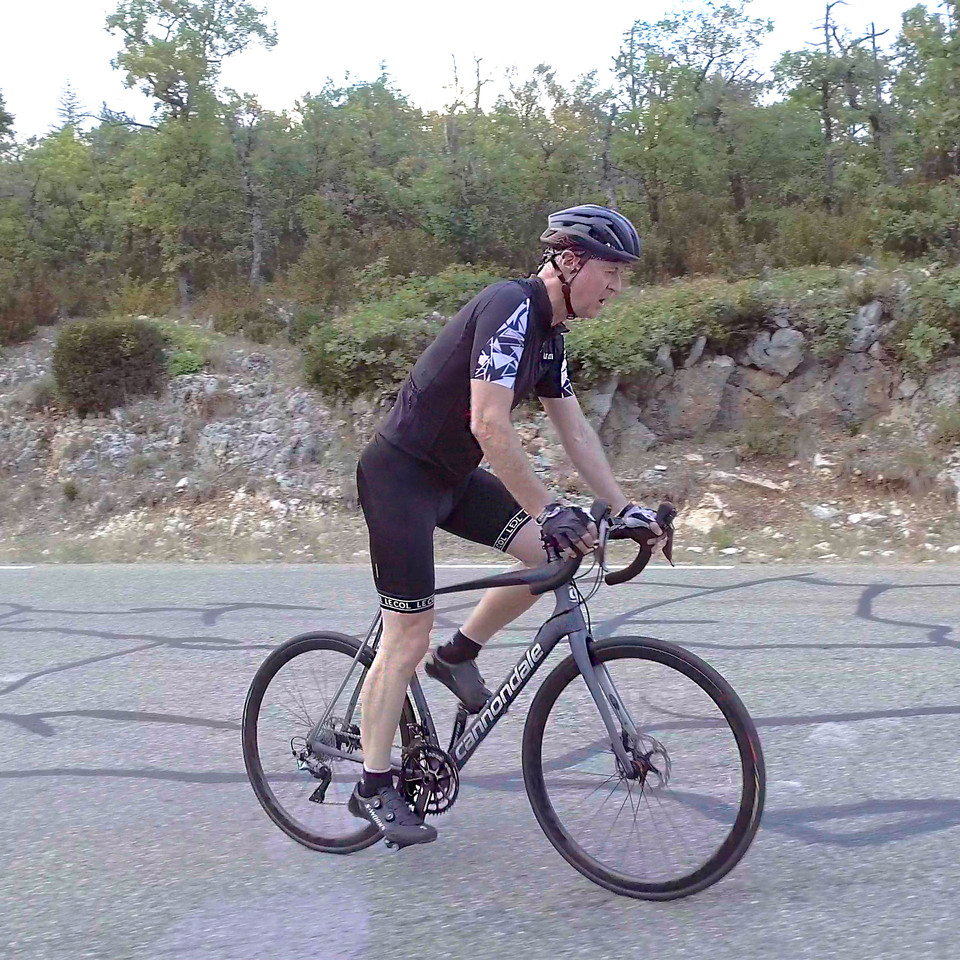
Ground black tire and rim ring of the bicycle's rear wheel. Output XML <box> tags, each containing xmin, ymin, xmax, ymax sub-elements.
<box><xmin>242</xmin><ymin>631</ymin><xmax>415</xmax><ymax>854</ymax></box>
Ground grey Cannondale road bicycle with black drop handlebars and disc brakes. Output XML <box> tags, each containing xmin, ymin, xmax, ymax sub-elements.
<box><xmin>242</xmin><ymin>501</ymin><xmax>766</xmax><ymax>900</ymax></box>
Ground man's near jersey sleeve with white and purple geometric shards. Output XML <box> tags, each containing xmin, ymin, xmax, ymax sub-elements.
<box><xmin>470</xmin><ymin>284</ymin><xmax>530</xmax><ymax>390</ymax></box>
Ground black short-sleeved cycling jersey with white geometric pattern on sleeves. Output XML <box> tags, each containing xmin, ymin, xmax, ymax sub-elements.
<box><xmin>378</xmin><ymin>277</ymin><xmax>573</xmax><ymax>483</ymax></box>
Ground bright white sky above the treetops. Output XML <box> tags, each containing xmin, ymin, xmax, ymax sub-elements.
<box><xmin>0</xmin><ymin>0</ymin><xmax>933</xmax><ymax>139</ymax></box>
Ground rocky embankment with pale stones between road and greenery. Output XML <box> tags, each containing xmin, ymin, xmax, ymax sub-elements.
<box><xmin>0</xmin><ymin>302</ymin><xmax>960</xmax><ymax>562</ymax></box>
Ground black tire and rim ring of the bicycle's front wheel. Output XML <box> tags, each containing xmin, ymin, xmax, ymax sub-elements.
<box><xmin>523</xmin><ymin>637</ymin><xmax>766</xmax><ymax>900</ymax></box>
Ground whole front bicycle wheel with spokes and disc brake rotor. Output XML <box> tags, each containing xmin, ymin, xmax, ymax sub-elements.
<box><xmin>523</xmin><ymin>637</ymin><xmax>766</xmax><ymax>900</ymax></box>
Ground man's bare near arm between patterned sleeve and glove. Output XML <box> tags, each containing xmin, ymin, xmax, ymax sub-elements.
<box><xmin>470</xmin><ymin>380</ymin><xmax>553</xmax><ymax>517</ymax></box>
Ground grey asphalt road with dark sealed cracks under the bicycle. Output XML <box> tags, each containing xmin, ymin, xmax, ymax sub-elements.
<box><xmin>0</xmin><ymin>564</ymin><xmax>960</xmax><ymax>960</ymax></box>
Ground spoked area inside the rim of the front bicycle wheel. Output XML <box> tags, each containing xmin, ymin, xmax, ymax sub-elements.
<box><xmin>539</xmin><ymin>652</ymin><xmax>745</xmax><ymax>887</ymax></box>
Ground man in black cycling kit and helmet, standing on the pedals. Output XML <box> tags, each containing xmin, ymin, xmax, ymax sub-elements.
<box><xmin>348</xmin><ymin>204</ymin><xmax>661</xmax><ymax>846</ymax></box>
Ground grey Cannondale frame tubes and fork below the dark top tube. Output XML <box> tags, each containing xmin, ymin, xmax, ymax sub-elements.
<box><xmin>308</xmin><ymin>583</ymin><xmax>637</xmax><ymax>778</ymax></box>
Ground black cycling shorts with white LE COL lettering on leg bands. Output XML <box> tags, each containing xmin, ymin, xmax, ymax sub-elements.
<box><xmin>357</xmin><ymin>436</ymin><xmax>530</xmax><ymax>613</ymax></box>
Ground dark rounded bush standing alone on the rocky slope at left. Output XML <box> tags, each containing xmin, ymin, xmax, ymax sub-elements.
<box><xmin>53</xmin><ymin>317</ymin><xmax>166</xmax><ymax>416</ymax></box>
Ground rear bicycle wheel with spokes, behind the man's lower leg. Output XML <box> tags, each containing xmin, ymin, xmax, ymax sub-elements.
<box><xmin>242</xmin><ymin>633</ymin><xmax>416</xmax><ymax>853</ymax></box>
